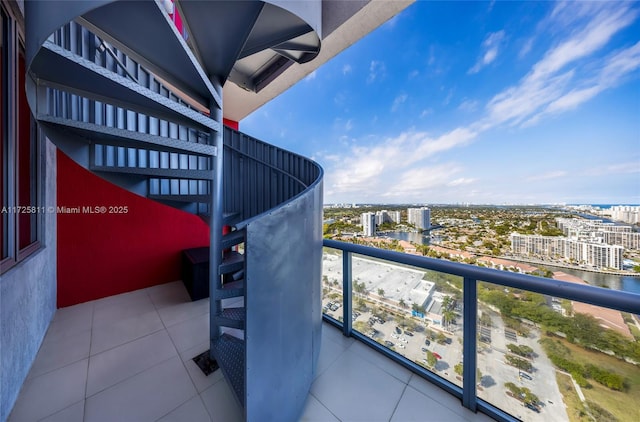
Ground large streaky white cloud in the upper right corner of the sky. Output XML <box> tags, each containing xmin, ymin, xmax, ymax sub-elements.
<box><xmin>484</xmin><ymin>3</ymin><xmax>640</xmax><ymax>126</ymax></box>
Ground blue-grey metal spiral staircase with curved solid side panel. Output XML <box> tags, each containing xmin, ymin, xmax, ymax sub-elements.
<box><xmin>25</xmin><ymin>0</ymin><xmax>322</xmax><ymax>421</ymax></box>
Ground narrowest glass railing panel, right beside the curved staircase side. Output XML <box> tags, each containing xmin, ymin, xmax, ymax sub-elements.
<box><xmin>322</xmin><ymin>247</ymin><xmax>343</xmax><ymax>321</ymax></box>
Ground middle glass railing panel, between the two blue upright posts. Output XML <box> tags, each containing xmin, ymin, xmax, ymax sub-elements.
<box><xmin>352</xmin><ymin>254</ymin><xmax>463</xmax><ymax>386</ymax></box>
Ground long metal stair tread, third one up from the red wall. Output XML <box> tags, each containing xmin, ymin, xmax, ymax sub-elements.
<box><xmin>36</xmin><ymin>114</ymin><xmax>216</xmax><ymax>156</ymax></box>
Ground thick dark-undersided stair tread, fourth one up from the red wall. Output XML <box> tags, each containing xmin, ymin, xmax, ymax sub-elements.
<box><xmin>32</xmin><ymin>41</ymin><xmax>221</xmax><ymax>131</ymax></box>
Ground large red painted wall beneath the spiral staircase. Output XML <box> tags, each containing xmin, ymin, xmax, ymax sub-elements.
<box><xmin>57</xmin><ymin>151</ymin><xmax>209</xmax><ymax>307</ymax></box>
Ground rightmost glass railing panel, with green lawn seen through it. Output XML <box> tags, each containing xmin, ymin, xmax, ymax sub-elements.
<box><xmin>476</xmin><ymin>282</ymin><xmax>640</xmax><ymax>421</ymax></box>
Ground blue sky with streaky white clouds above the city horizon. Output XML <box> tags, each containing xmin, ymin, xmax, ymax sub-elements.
<box><xmin>240</xmin><ymin>1</ymin><xmax>640</xmax><ymax>204</ymax></box>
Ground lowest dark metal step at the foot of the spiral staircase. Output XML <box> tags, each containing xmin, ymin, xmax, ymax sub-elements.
<box><xmin>211</xmin><ymin>334</ymin><xmax>245</xmax><ymax>407</ymax></box>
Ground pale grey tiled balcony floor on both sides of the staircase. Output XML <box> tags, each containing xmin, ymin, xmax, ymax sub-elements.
<box><xmin>9</xmin><ymin>282</ymin><xmax>492</xmax><ymax>422</ymax></box>
